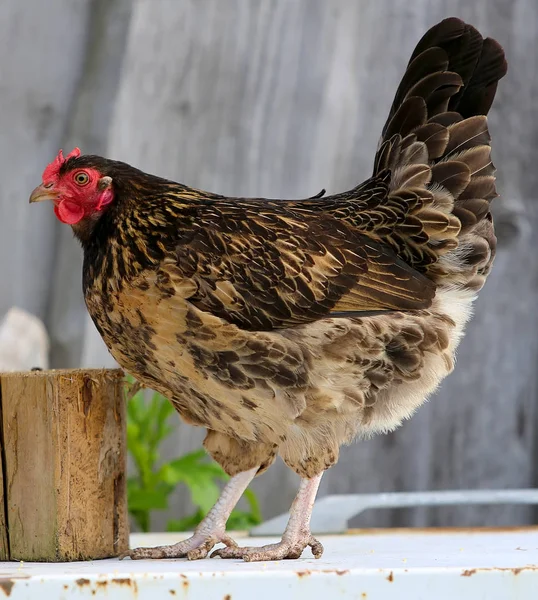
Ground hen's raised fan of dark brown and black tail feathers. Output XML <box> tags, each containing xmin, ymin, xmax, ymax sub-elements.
<box><xmin>374</xmin><ymin>18</ymin><xmax>506</xmax><ymax>290</ymax></box>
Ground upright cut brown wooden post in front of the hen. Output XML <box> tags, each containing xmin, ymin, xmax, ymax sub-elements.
<box><xmin>0</xmin><ymin>369</ymin><xmax>129</xmax><ymax>561</ymax></box>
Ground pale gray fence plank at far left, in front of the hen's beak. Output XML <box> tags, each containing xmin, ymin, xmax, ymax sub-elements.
<box><xmin>0</xmin><ymin>0</ymin><xmax>89</xmax><ymax>318</ymax></box>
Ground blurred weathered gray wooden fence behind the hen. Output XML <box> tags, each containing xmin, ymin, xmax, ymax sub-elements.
<box><xmin>0</xmin><ymin>0</ymin><xmax>538</xmax><ymax>529</ymax></box>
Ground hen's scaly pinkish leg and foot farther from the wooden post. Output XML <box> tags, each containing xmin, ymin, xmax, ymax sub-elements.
<box><xmin>211</xmin><ymin>473</ymin><xmax>323</xmax><ymax>562</ymax></box>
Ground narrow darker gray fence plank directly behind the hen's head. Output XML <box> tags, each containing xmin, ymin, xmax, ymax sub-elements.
<box><xmin>47</xmin><ymin>0</ymin><xmax>132</xmax><ymax>368</ymax></box>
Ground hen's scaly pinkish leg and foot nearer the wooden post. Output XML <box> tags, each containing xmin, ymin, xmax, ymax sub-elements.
<box><xmin>122</xmin><ymin>467</ymin><xmax>258</xmax><ymax>560</ymax></box>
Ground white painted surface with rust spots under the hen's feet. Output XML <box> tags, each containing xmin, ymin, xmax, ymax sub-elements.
<box><xmin>0</xmin><ymin>528</ymin><xmax>538</xmax><ymax>600</ymax></box>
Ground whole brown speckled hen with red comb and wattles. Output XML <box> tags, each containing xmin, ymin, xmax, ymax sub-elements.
<box><xmin>30</xmin><ymin>18</ymin><xmax>506</xmax><ymax>561</ymax></box>
